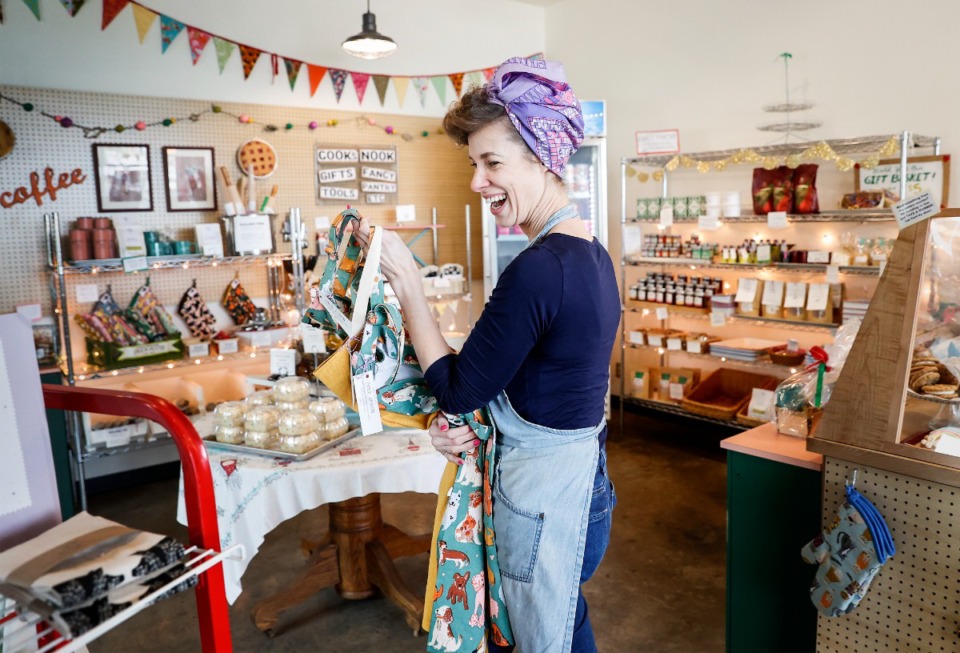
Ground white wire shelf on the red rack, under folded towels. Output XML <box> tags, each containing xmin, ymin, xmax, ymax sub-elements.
<box><xmin>0</xmin><ymin>544</ymin><xmax>246</xmax><ymax>653</ymax></box>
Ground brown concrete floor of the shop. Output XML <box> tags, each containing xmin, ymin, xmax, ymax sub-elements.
<box><xmin>90</xmin><ymin>412</ymin><xmax>733</xmax><ymax>653</ymax></box>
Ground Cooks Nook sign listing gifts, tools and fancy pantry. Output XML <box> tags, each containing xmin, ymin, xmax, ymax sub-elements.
<box><xmin>316</xmin><ymin>145</ymin><xmax>398</xmax><ymax>204</ymax></box>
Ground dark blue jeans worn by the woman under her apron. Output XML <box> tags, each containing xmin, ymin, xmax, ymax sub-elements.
<box><xmin>487</xmin><ymin>449</ymin><xmax>617</xmax><ymax>653</ymax></box>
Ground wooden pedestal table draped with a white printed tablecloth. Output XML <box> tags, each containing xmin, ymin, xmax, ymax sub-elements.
<box><xmin>177</xmin><ymin>429</ymin><xmax>446</xmax><ymax>634</ymax></box>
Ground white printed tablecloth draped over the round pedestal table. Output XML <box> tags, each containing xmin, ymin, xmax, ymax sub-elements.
<box><xmin>177</xmin><ymin>429</ymin><xmax>446</xmax><ymax>603</ymax></box>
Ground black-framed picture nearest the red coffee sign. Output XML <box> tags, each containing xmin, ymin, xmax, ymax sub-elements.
<box><xmin>93</xmin><ymin>143</ymin><xmax>153</xmax><ymax>213</ymax></box>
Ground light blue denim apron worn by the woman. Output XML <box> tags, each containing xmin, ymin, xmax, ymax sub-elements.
<box><xmin>489</xmin><ymin>205</ymin><xmax>606</xmax><ymax>653</ymax></box>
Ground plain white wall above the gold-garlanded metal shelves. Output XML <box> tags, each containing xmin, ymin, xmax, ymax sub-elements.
<box><xmin>546</xmin><ymin>0</ymin><xmax>960</xmax><ymax>242</ymax></box>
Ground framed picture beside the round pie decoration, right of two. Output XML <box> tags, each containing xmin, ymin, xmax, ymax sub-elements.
<box><xmin>163</xmin><ymin>147</ymin><xmax>217</xmax><ymax>211</ymax></box>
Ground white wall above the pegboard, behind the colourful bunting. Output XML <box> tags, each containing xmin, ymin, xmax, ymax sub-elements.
<box><xmin>0</xmin><ymin>0</ymin><xmax>545</xmax><ymax>116</ymax></box>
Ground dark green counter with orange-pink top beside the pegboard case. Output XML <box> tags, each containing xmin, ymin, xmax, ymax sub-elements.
<box><xmin>720</xmin><ymin>424</ymin><xmax>823</xmax><ymax>653</ymax></box>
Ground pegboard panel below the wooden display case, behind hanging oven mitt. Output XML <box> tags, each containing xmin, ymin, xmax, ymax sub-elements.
<box><xmin>811</xmin><ymin>458</ymin><xmax>960</xmax><ymax>653</ymax></box>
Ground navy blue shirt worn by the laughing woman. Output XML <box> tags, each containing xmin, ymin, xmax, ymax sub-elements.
<box><xmin>425</xmin><ymin>234</ymin><xmax>620</xmax><ymax>445</ymax></box>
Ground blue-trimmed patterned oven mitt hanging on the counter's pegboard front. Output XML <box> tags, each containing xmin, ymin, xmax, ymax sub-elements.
<box><xmin>800</xmin><ymin>485</ymin><xmax>896</xmax><ymax>617</ymax></box>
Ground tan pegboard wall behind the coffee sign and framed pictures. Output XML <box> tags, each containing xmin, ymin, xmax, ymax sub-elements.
<box><xmin>0</xmin><ymin>86</ymin><xmax>482</xmax><ymax>336</ymax></box>
